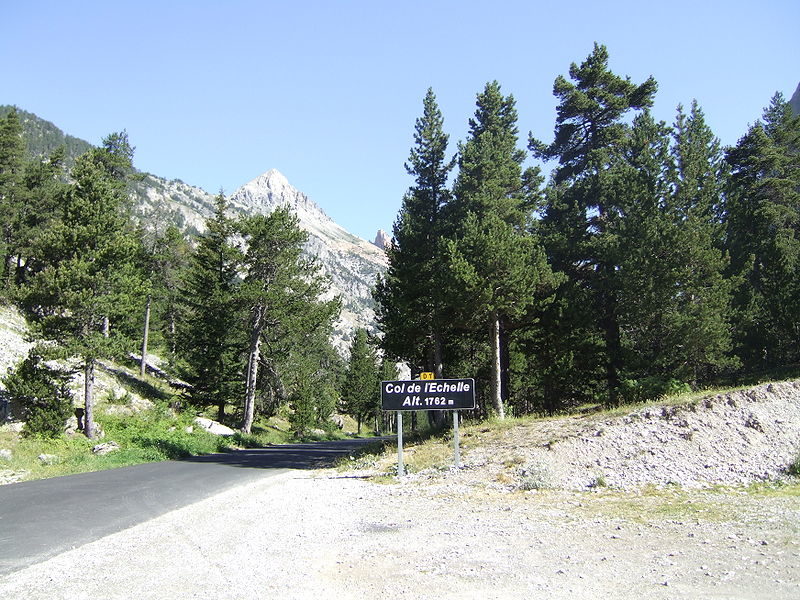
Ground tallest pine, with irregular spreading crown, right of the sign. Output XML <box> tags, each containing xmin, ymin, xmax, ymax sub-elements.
<box><xmin>529</xmin><ymin>44</ymin><xmax>657</xmax><ymax>404</ymax></box>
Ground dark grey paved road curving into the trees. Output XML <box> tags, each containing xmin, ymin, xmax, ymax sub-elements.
<box><xmin>0</xmin><ymin>440</ymin><xmax>384</xmax><ymax>575</ymax></box>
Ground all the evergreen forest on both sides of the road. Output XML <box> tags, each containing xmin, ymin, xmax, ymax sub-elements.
<box><xmin>0</xmin><ymin>45</ymin><xmax>800</xmax><ymax>437</ymax></box>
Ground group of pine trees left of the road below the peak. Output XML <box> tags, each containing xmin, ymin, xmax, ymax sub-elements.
<box><xmin>0</xmin><ymin>118</ymin><xmax>360</xmax><ymax>438</ymax></box>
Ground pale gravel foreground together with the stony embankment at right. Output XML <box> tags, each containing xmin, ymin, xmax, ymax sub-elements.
<box><xmin>0</xmin><ymin>382</ymin><xmax>800</xmax><ymax>600</ymax></box>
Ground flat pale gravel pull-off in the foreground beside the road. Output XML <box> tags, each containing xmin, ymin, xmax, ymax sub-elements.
<box><xmin>0</xmin><ymin>471</ymin><xmax>800</xmax><ymax>600</ymax></box>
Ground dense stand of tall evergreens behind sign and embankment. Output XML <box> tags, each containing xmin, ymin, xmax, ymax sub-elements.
<box><xmin>375</xmin><ymin>44</ymin><xmax>800</xmax><ymax>416</ymax></box>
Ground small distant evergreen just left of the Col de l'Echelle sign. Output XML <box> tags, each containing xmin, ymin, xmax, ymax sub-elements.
<box><xmin>341</xmin><ymin>328</ymin><xmax>380</xmax><ymax>434</ymax></box>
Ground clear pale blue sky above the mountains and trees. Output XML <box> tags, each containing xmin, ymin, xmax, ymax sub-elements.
<box><xmin>0</xmin><ymin>0</ymin><xmax>800</xmax><ymax>239</ymax></box>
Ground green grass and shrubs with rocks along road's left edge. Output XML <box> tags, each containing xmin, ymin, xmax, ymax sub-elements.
<box><xmin>0</xmin><ymin>352</ymin><xmax>368</xmax><ymax>483</ymax></box>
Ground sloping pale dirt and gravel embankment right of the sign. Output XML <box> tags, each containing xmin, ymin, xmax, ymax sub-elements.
<box><xmin>454</xmin><ymin>381</ymin><xmax>800</xmax><ymax>490</ymax></box>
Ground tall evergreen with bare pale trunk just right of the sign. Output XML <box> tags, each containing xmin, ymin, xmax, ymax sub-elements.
<box><xmin>447</xmin><ymin>81</ymin><xmax>555</xmax><ymax>418</ymax></box>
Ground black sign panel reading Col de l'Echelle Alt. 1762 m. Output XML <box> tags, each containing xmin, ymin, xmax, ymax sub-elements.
<box><xmin>381</xmin><ymin>379</ymin><xmax>475</xmax><ymax>410</ymax></box>
